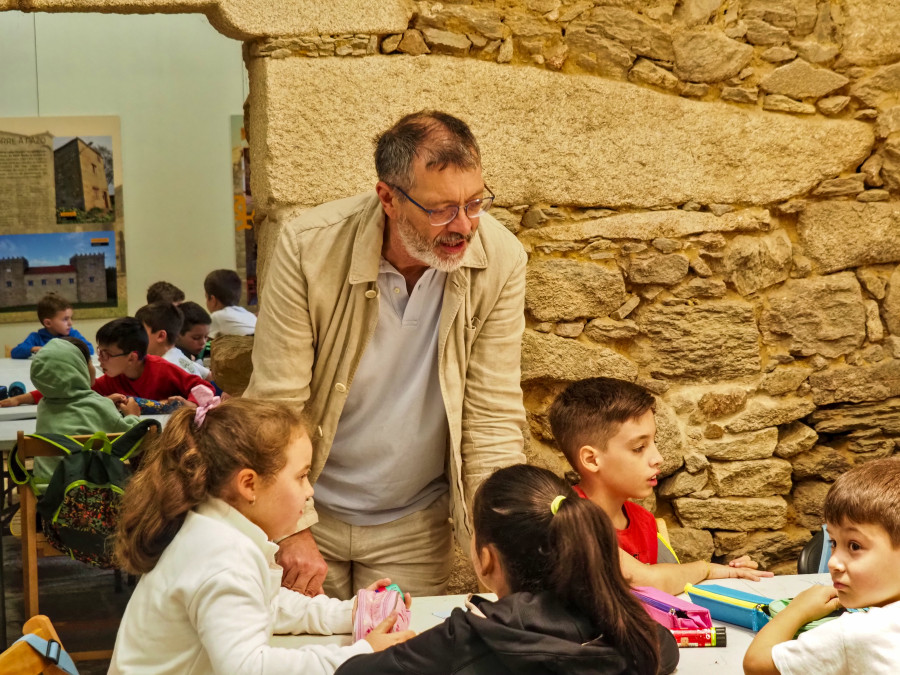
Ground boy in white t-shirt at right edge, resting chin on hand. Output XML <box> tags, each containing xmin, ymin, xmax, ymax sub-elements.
<box><xmin>744</xmin><ymin>457</ymin><xmax>900</xmax><ymax>675</ymax></box>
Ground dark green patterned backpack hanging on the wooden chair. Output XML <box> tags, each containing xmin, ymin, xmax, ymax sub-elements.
<box><xmin>9</xmin><ymin>419</ymin><xmax>161</xmax><ymax>569</ymax></box>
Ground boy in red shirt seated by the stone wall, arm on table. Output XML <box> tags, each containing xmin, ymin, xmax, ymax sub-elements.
<box><xmin>550</xmin><ymin>377</ymin><xmax>772</xmax><ymax>595</ymax></box>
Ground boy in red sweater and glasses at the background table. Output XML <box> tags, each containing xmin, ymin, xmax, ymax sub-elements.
<box><xmin>93</xmin><ymin>316</ymin><xmax>213</xmax><ymax>403</ymax></box>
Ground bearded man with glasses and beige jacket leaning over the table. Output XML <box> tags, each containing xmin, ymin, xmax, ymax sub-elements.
<box><xmin>244</xmin><ymin>111</ymin><xmax>526</xmax><ymax>598</ymax></box>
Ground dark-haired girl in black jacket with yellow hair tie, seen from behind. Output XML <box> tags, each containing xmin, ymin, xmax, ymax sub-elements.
<box><xmin>338</xmin><ymin>464</ymin><xmax>678</xmax><ymax>675</ymax></box>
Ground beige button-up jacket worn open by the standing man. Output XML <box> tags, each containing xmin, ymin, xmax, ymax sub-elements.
<box><xmin>244</xmin><ymin>192</ymin><xmax>526</xmax><ymax>551</ymax></box>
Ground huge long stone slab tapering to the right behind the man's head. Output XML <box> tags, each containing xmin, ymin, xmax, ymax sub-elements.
<box><xmin>248</xmin><ymin>58</ymin><xmax>873</xmax><ymax>210</ymax></box>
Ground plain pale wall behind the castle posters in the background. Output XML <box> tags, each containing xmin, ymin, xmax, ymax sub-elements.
<box><xmin>0</xmin><ymin>12</ymin><xmax>247</xmax><ymax>352</ymax></box>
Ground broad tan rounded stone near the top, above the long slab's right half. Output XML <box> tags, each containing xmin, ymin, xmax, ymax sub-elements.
<box><xmin>673</xmin><ymin>26</ymin><xmax>753</xmax><ymax>82</ymax></box>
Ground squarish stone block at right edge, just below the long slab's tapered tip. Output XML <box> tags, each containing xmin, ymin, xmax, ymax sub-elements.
<box><xmin>797</xmin><ymin>202</ymin><xmax>900</xmax><ymax>272</ymax></box>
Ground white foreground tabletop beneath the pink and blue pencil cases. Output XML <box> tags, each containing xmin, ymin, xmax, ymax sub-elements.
<box><xmin>270</xmin><ymin>574</ymin><xmax>831</xmax><ymax>675</ymax></box>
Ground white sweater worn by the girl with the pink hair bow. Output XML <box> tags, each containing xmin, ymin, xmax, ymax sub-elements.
<box><xmin>109</xmin><ymin>499</ymin><xmax>372</xmax><ymax>675</ymax></box>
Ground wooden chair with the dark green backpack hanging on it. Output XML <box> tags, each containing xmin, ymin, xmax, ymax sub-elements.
<box><xmin>14</xmin><ymin>431</ymin><xmax>148</xmax><ymax>660</ymax></box>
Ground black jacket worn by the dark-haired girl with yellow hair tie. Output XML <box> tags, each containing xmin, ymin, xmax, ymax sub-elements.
<box><xmin>335</xmin><ymin>593</ymin><xmax>678</xmax><ymax>675</ymax></box>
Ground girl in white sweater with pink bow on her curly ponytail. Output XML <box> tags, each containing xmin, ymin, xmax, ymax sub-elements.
<box><xmin>109</xmin><ymin>396</ymin><xmax>412</xmax><ymax>675</ymax></box>
